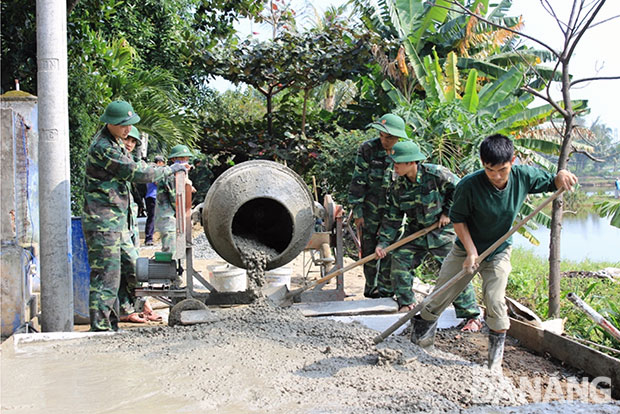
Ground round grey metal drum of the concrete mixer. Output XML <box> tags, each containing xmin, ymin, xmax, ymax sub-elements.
<box><xmin>202</xmin><ymin>160</ymin><xmax>315</xmax><ymax>270</ymax></box>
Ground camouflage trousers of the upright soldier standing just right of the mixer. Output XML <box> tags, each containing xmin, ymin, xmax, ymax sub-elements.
<box><xmin>361</xmin><ymin>217</ymin><xmax>393</xmax><ymax>298</ymax></box>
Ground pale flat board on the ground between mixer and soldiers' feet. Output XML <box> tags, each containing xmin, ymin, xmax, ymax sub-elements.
<box><xmin>292</xmin><ymin>298</ymin><xmax>398</xmax><ymax>316</ymax></box>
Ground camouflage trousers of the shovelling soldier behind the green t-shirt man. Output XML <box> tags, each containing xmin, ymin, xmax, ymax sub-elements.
<box><xmin>388</xmin><ymin>243</ymin><xmax>480</xmax><ymax>319</ymax></box>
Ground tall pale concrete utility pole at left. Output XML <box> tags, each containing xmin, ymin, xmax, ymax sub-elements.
<box><xmin>37</xmin><ymin>0</ymin><xmax>73</xmax><ymax>332</ymax></box>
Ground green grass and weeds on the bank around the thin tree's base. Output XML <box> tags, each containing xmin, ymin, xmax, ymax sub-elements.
<box><xmin>506</xmin><ymin>248</ymin><xmax>620</xmax><ymax>349</ymax></box>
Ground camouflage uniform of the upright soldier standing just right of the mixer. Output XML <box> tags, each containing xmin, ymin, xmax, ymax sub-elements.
<box><xmin>349</xmin><ymin>138</ymin><xmax>394</xmax><ymax>297</ymax></box>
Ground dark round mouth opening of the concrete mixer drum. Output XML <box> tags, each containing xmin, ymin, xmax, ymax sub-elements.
<box><xmin>232</xmin><ymin>198</ymin><xmax>293</xmax><ymax>253</ymax></box>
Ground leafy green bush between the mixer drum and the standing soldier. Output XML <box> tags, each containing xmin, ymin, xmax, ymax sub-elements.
<box><xmin>307</xmin><ymin>128</ymin><xmax>377</xmax><ymax>205</ymax></box>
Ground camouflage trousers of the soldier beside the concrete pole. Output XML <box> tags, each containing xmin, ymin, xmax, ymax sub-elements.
<box><xmin>84</xmin><ymin>225</ymin><xmax>138</xmax><ymax>331</ymax></box>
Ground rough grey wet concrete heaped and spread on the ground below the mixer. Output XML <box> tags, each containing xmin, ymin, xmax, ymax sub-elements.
<box><xmin>62</xmin><ymin>301</ymin><xmax>525</xmax><ymax>414</ymax></box>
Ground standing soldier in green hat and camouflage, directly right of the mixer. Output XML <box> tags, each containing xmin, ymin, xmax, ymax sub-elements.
<box><xmin>348</xmin><ymin>114</ymin><xmax>407</xmax><ymax>298</ymax></box>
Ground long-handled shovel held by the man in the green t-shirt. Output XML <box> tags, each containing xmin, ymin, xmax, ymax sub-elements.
<box><xmin>373</xmin><ymin>188</ymin><xmax>565</xmax><ymax>344</ymax></box>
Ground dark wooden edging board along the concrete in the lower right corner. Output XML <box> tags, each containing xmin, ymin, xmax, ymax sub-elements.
<box><xmin>543</xmin><ymin>331</ymin><xmax>620</xmax><ymax>399</ymax></box>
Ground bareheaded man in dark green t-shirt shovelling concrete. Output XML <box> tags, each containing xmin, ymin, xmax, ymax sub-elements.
<box><xmin>411</xmin><ymin>135</ymin><xmax>577</xmax><ymax>370</ymax></box>
